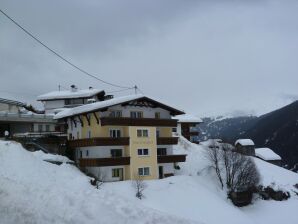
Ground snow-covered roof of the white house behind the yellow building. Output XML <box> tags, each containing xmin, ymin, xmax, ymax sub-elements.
<box><xmin>37</xmin><ymin>89</ymin><xmax>104</xmax><ymax>101</ymax></box>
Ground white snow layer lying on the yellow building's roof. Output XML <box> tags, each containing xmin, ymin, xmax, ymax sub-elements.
<box><xmin>54</xmin><ymin>94</ymin><xmax>184</xmax><ymax>119</ymax></box>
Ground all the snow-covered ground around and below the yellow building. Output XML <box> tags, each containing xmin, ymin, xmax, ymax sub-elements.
<box><xmin>0</xmin><ymin>138</ymin><xmax>298</xmax><ymax>224</ymax></box>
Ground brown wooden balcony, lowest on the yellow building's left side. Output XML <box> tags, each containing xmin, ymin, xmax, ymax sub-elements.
<box><xmin>79</xmin><ymin>157</ymin><xmax>130</xmax><ymax>167</ymax></box>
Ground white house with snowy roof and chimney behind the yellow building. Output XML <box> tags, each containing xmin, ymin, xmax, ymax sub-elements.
<box><xmin>37</xmin><ymin>85</ymin><xmax>106</xmax><ymax>114</ymax></box>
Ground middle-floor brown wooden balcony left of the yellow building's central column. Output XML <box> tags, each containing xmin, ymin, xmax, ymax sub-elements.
<box><xmin>68</xmin><ymin>137</ymin><xmax>129</xmax><ymax>148</ymax></box>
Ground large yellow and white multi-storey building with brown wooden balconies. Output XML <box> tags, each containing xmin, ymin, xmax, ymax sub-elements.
<box><xmin>55</xmin><ymin>95</ymin><xmax>186</xmax><ymax>181</ymax></box>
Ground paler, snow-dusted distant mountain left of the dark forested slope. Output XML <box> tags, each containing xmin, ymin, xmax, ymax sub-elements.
<box><xmin>199</xmin><ymin>116</ymin><xmax>258</xmax><ymax>142</ymax></box>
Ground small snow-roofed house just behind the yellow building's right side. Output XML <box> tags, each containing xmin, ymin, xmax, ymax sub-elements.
<box><xmin>173</xmin><ymin>114</ymin><xmax>203</xmax><ymax>143</ymax></box>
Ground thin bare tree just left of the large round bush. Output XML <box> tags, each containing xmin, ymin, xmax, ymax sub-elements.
<box><xmin>206</xmin><ymin>140</ymin><xmax>224</xmax><ymax>189</ymax></box>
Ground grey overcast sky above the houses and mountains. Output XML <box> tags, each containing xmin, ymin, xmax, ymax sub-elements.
<box><xmin>0</xmin><ymin>0</ymin><xmax>298</xmax><ymax>116</ymax></box>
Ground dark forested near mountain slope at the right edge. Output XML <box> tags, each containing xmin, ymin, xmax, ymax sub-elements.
<box><xmin>241</xmin><ymin>101</ymin><xmax>298</xmax><ymax>166</ymax></box>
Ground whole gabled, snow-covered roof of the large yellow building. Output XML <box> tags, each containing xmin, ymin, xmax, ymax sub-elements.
<box><xmin>54</xmin><ymin>94</ymin><xmax>184</xmax><ymax>119</ymax></box>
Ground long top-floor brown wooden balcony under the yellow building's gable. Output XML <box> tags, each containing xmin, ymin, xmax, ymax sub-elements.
<box><xmin>100</xmin><ymin>117</ymin><xmax>177</xmax><ymax>127</ymax></box>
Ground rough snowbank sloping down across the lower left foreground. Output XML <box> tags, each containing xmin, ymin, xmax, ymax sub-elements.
<box><xmin>0</xmin><ymin>141</ymin><xmax>197</xmax><ymax>224</ymax></box>
